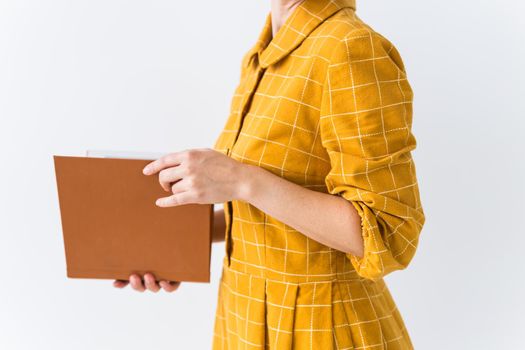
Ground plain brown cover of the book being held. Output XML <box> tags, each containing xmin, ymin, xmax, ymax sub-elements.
<box><xmin>53</xmin><ymin>155</ymin><xmax>213</xmax><ymax>282</ymax></box>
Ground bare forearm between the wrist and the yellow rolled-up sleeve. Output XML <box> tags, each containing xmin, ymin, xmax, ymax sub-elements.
<box><xmin>238</xmin><ymin>165</ymin><xmax>364</xmax><ymax>257</ymax></box>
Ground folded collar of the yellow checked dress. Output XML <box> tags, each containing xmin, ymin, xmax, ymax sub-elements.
<box><xmin>249</xmin><ymin>0</ymin><xmax>356</xmax><ymax>68</ymax></box>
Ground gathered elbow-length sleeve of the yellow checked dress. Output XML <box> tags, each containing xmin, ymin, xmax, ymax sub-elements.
<box><xmin>320</xmin><ymin>29</ymin><xmax>425</xmax><ymax>280</ymax></box>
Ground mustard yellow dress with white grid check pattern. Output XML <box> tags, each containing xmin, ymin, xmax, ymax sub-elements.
<box><xmin>213</xmin><ymin>0</ymin><xmax>425</xmax><ymax>350</ymax></box>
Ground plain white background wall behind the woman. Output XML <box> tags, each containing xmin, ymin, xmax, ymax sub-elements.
<box><xmin>0</xmin><ymin>0</ymin><xmax>525</xmax><ymax>350</ymax></box>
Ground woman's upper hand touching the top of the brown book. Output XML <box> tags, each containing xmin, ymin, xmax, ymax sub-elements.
<box><xmin>143</xmin><ymin>148</ymin><xmax>249</xmax><ymax>207</ymax></box>
